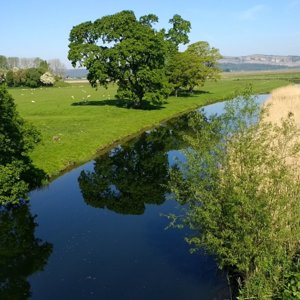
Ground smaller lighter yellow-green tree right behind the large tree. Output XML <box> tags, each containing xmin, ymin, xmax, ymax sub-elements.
<box><xmin>167</xmin><ymin>42</ymin><xmax>221</xmax><ymax>95</ymax></box>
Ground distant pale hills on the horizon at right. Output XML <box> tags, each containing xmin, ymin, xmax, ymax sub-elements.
<box><xmin>219</xmin><ymin>54</ymin><xmax>300</xmax><ymax>71</ymax></box>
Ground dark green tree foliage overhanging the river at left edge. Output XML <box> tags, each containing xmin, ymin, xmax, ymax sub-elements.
<box><xmin>0</xmin><ymin>86</ymin><xmax>43</xmax><ymax>206</ymax></box>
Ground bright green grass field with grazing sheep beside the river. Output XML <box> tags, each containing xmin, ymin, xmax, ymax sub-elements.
<box><xmin>10</xmin><ymin>73</ymin><xmax>300</xmax><ymax>176</ymax></box>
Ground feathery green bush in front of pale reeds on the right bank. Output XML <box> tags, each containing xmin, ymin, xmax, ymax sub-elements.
<box><xmin>171</xmin><ymin>91</ymin><xmax>300</xmax><ymax>299</ymax></box>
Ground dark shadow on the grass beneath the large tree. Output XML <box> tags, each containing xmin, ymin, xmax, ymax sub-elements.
<box><xmin>71</xmin><ymin>99</ymin><xmax>165</xmax><ymax>110</ymax></box>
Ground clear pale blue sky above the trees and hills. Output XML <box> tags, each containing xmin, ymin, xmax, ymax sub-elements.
<box><xmin>0</xmin><ymin>0</ymin><xmax>300</xmax><ymax>66</ymax></box>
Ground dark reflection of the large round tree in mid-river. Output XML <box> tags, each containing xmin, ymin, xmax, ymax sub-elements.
<box><xmin>78</xmin><ymin>116</ymin><xmax>188</xmax><ymax>215</ymax></box>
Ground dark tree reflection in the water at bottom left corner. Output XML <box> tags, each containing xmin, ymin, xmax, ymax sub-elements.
<box><xmin>0</xmin><ymin>205</ymin><xmax>52</xmax><ymax>300</ymax></box>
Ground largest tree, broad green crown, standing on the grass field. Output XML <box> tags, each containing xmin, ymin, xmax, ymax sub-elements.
<box><xmin>68</xmin><ymin>11</ymin><xmax>190</xmax><ymax>107</ymax></box>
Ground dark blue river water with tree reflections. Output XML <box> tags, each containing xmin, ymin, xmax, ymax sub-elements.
<box><xmin>0</xmin><ymin>95</ymin><xmax>268</xmax><ymax>300</ymax></box>
